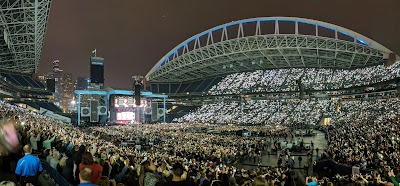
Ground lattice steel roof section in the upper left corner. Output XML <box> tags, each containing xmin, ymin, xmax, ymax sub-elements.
<box><xmin>0</xmin><ymin>0</ymin><xmax>51</xmax><ymax>73</ymax></box>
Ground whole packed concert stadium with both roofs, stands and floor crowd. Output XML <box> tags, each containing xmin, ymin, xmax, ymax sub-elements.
<box><xmin>0</xmin><ymin>0</ymin><xmax>400</xmax><ymax>186</ymax></box>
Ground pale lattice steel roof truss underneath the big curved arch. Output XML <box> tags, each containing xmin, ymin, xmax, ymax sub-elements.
<box><xmin>149</xmin><ymin>35</ymin><xmax>384</xmax><ymax>82</ymax></box>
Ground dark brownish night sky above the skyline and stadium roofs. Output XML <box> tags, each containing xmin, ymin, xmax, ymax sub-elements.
<box><xmin>39</xmin><ymin>0</ymin><xmax>400</xmax><ymax>88</ymax></box>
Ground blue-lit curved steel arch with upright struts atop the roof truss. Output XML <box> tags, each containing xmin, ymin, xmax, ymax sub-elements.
<box><xmin>146</xmin><ymin>17</ymin><xmax>393</xmax><ymax>80</ymax></box>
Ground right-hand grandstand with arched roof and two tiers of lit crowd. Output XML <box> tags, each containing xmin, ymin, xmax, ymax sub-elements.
<box><xmin>146</xmin><ymin>17</ymin><xmax>399</xmax><ymax>125</ymax></box>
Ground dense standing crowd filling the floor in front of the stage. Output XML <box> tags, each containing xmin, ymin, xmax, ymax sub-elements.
<box><xmin>0</xmin><ymin>102</ymin><xmax>296</xmax><ymax>186</ymax></box>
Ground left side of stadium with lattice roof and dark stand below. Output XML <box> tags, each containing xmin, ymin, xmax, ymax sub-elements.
<box><xmin>0</xmin><ymin>0</ymin><xmax>57</xmax><ymax>112</ymax></box>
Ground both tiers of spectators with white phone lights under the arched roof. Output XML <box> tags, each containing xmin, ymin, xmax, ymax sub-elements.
<box><xmin>173</xmin><ymin>62</ymin><xmax>400</xmax><ymax>125</ymax></box>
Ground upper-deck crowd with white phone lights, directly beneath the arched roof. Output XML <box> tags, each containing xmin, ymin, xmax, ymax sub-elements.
<box><xmin>208</xmin><ymin>61</ymin><xmax>400</xmax><ymax>95</ymax></box>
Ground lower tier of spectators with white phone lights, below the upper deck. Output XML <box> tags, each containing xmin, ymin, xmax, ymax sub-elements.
<box><xmin>173</xmin><ymin>100</ymin><xmax>337</xmax><ymax>125</ymax></box>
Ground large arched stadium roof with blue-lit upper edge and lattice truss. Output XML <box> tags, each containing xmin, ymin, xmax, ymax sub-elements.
<box><xmin>146</xmin><ymin>17</ymin><xmax>393</xmax><ymax>83</ymax></box>
